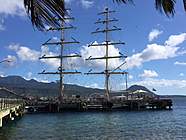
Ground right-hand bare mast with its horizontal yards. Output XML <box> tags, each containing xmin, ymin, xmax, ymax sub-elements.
<box><xmin>85</xmin><ymin>8</ymin><xmax>128</xmax><ymax>101</ymax></box>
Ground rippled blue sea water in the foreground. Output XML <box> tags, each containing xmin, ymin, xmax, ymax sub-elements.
<box><xmin>0</xmin><ymin>98</ymin><xmax>186</xmax><ymax>140</ymax></box>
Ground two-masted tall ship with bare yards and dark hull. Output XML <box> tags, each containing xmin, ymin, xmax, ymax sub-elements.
<box><xmin>34</xmin><ymin>8</ymin><xmax>172</xmax><ymax>112</ymax></box>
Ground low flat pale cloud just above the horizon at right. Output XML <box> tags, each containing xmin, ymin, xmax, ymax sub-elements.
<box><xmin>133</xmin><ymin>79</ymin><xmax>186</xmax><ymax>88</ymax></box>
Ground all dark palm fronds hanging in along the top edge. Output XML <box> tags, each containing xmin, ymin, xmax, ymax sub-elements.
<box><xmin>24</xmin><ymin>0</ymin><xmax>186</xmax><ymax>30</ymax></box>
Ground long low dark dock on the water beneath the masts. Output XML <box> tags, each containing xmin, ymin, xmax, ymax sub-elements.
<box><xmin>24</xmin><ymin>99</ymin><xmax>172</xmax><ymax>113</ymax></box>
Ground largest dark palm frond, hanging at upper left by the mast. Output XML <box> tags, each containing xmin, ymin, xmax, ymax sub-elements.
<box><xmin>24</xmin><ymin>0</ymin><xmax>66</xmax><ymax>30</ymax></box>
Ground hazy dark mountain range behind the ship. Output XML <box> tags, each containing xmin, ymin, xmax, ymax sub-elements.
<box><xmin>0</xmin><ymin>76</ymin><xmax>155</xmax><ymax>97</ymax></box>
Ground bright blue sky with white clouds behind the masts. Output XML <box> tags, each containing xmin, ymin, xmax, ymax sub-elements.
<box><xmin>0</xmin><ymin>0</ymin><xmax>186</xmax><ymax>95</ymax></box>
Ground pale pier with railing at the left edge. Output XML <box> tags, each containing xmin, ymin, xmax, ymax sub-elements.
<box><xmin>0</xmin><ymin>98</ymin><xmax>24</xmax><ymax>127</ymax></box>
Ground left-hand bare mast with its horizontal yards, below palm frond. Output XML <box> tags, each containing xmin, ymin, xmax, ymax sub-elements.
<box><xmin>39</xmin><ymin>10</ymin><xmax>81</xmax><ymax>101</ymax></box>
